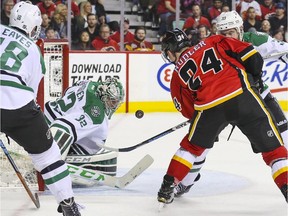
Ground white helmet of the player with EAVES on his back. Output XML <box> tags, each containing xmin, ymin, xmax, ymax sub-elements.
<box><xmin>10</xmin><ymin>1</ymin><xmax>42</xmax><ymax>40</ymax></box>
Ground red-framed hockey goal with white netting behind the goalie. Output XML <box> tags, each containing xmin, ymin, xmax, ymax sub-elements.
<box><xmin>0</xmin><ymin>40</ymin><xmax>69</xmax><ymax>191</ymax></box>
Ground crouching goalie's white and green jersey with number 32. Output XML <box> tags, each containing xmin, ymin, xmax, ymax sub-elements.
<box><xmin>44</xmin><ymin>81</ymin><xmax>109</xmax><ymax>154</ymax></box>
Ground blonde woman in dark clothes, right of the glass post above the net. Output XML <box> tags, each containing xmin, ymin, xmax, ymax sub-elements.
<box><xmin>73</xmin><ymin>1</ymin><xmax>92</xmax><ymax>37</ymax></box>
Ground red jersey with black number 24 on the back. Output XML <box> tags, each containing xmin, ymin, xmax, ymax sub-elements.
<box><xmin>170</xmin><ymin>35</ymin><xmax>263</xmax><ymax>113</ymax></box>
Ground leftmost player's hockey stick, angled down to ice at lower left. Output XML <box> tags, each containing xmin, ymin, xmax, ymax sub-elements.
<box><xmin>0</xmin><ymin>140</ymin><xmax>40</xmax><ymax>208</ymax></box>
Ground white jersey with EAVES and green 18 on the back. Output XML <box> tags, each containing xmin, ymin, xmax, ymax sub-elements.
<box><xmin>0</xmin><ymin>25</ymin><xmax>45</xmax><ymax>110</ymax></box>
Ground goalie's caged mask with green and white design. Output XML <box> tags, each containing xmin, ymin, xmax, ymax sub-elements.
<box><xmin>97</xmin><ymin>78</ymin><xmax>125</xmax><ymax>119</ymax></box>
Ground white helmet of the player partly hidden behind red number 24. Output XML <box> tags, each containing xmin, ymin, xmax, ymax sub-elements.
<box><xmin>216</xmin><ymin>10</ymin><xmax>244</xmax><ymax>40</ymax></box>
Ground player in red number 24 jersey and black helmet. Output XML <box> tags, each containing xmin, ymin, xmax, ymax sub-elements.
<box><xmin>158</xmin><ymin>29</ymin><xmax>288</xmax><ymax>204</ymax></box>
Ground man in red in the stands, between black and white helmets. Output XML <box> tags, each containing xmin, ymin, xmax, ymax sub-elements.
<box><xmin>183</xmin><ymin>5</ymin><xmax>211</xmax><ymax>34</ymax></box>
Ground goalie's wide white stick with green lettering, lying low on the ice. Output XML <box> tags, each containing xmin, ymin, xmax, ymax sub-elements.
<box><xmin>67</xmin><ymin>154</ymin><xmax>154</xmax><ymax>188</ymax></box>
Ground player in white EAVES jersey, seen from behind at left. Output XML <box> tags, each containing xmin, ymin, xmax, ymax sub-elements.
<box><xmin>0</xmin><ymin>2</ymin><xmax>81</xmax><ymax>216</ymax></box>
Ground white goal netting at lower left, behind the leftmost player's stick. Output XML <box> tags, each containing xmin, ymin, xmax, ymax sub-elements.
<box><xmin>0</xmin><ymin>134</ymin><xmax>38</xmax><ymax>187</ymax></box>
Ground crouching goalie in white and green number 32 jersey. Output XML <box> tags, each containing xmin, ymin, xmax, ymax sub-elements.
<box><xmin>44</xmin><ymin>78</ymin><xmax>124</xmax><ymax>179</ymax></box>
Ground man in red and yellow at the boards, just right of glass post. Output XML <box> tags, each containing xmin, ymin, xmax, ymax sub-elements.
<box><xmin>125</xmin><ymin>26</ymin><xmax>155</xmax><ymax>51</ymax></box>
